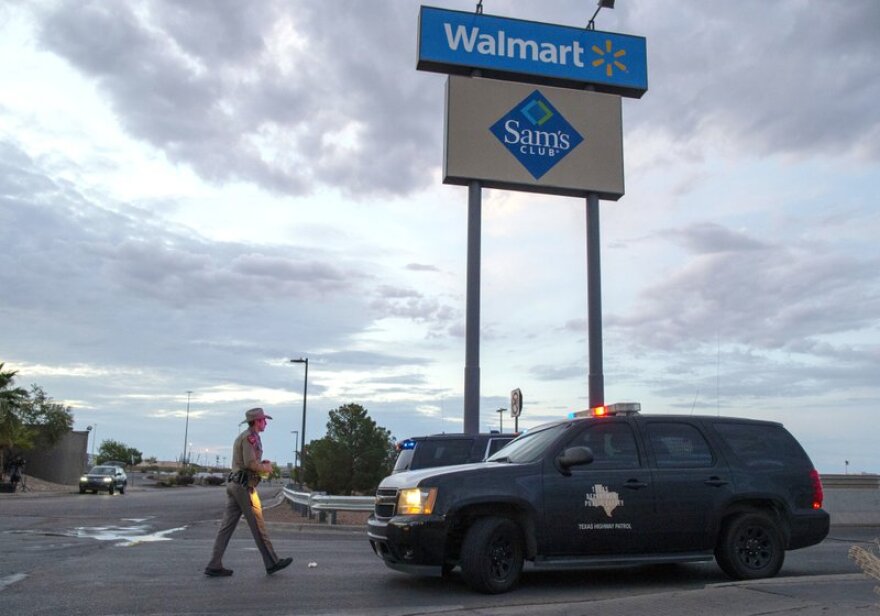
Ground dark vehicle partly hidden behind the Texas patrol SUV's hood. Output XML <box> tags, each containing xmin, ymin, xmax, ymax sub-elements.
<box><xmin>391</xmin><ymin>432</ymin><xmax>516</xmax><ymax>473</ymax></box>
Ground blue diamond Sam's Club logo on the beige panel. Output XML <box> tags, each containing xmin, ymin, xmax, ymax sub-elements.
<box><xmin>489</xmin><ymin>90</ymin><xmax>584</xmax><ymax>180</ymax></box>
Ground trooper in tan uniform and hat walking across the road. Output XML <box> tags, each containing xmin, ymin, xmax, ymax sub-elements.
<box><xmin>205</xmin><ymin>407</ymin><xmax>293</xmax><ymax>577</ymax></box>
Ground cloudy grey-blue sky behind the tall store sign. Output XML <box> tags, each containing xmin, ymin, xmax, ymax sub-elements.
<box><xmin>0</xmin><ymin>0</ymin><xmax>880</xmax><ymax>473</ymax></box>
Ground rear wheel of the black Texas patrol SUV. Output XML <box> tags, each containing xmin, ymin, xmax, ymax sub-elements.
<box><xmin>715</xmin><ymin>513</ymin><xmax>785</xmax><ymax>580</ymax></box>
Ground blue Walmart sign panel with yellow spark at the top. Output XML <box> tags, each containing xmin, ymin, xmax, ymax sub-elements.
<box><xmin>417</xmin><ymin>6</ymin><xmax>648</xmax><ymax>98</ymax></box>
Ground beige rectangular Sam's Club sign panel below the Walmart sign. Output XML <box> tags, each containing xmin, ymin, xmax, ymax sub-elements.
<box><xmin>443</xmin><ymin>75</ymin><xmax>624</xmax><ymax>201</ymax></box>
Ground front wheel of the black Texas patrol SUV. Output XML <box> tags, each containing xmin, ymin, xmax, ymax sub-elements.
<box><xmin>461</xmin><ymin>518</ymin><xmax>523</xmax><ymax>594</ymax></box>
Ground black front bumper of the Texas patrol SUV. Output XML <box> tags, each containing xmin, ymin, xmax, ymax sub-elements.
<box><xmin>367</xmin><ymin>515</ymin><xmax>447</xmax><ymax>575</ymax></box>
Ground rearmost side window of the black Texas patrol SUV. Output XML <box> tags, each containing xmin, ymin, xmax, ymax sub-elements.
<box><xmin>715</xmin><ymin>422</ymin><xmax>807</xmax><ymax>469</ymax></box>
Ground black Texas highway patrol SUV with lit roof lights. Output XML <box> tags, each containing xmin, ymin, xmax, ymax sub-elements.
<box><xmin>367</xmin><ymin>403</ymin><xmax>830</xmax><ymax>593</ymax></box>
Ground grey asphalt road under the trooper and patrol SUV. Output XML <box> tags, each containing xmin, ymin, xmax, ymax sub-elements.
<box><xmin>0</xmin><ymin>486</ymin><xmax>880</xmax><ymax>616</ymax></box>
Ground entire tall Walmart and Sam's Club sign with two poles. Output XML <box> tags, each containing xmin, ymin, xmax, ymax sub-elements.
<box><xmin>417</xmin><ymin>0</ymin><xmax>648</xmax><ymax>433</ymax></box>
